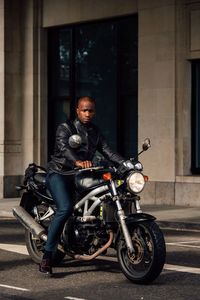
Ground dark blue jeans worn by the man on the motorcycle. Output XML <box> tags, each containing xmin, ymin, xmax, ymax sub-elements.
<box><xmin>45</xmin><ymin>172</ymin><xmax>73</xmax><ymax>251</ymax></box>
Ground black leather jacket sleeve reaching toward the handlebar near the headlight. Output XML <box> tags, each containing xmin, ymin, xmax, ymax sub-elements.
<box><xmin>97</xmin><ymin>133</ymin><xmax>125</xmax><ymax>166</ymax></box>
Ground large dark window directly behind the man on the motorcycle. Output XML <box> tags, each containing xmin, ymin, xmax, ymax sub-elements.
<box><xmin>48</xmin><ymin>15</ymin><xmax>138</xmax><ymax>158</ymax></box>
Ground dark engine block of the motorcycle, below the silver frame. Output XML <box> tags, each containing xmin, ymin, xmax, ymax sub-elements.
<box><xmin>62</xmin><ymin>217</ymin><xmax>108</xmax><ymax>255</ymax></box>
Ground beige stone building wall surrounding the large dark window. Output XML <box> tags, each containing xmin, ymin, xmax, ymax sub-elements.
<box><xmin>0</xmin><ymin>0</ymin><xmax>200</xmax><ymax>206</ymax></box>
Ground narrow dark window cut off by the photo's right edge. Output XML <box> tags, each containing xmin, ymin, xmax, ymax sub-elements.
<box><xmin>191</xmin><ymin>60</ymin><xmax>200</xmax><ymax>174</ymax></box>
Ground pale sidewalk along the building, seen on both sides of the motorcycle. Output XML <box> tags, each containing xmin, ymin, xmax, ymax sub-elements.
<box><xmin>0</xmin><ymin>198</ymin><xmax>200</xmax><ymax>232</ymax></box>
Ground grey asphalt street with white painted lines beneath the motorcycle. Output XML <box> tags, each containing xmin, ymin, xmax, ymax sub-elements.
<box><xmin>0</xmin><ymin>219</ymin><xmax>200</xmax><ymax>300</ymax></box>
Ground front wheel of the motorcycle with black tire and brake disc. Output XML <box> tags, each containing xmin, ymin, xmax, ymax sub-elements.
<box><xmin>117</xmin><ymin>221</ymin><xmax>166</xmax><ymax>284</ymax></box>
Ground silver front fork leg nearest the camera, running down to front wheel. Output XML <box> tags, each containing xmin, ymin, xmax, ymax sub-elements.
<box><xmin>110</xmin><ymin>181</ymin><xmax>135</xmax><ymax>254</ymax></box>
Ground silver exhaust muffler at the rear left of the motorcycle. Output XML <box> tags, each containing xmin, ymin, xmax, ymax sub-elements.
<box><xmin>12</xmin><ymin>206</ymin><xmax>47</xmax><ymax>241</ymax></box>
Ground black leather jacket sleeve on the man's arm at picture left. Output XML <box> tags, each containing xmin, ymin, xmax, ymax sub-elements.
<box><xmin>56</xmin><ymin>124</ymin><xmax>78</xmax><ymax>167</ymax></box>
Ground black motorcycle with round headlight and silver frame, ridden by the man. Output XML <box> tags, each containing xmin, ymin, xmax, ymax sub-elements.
<box><xmin>13</xmin><ymin>136</ymin><xmax>166</xmax><ymax>284</ymax></box>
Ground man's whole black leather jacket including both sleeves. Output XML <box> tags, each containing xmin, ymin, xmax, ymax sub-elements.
<box><xmin>48</xmin><ymin>119</ymin><xmax>124</xmax><ymax>173</ymax></box>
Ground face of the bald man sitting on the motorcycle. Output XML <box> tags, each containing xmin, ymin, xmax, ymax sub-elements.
<box><xmin>76</xmin><ymin>98</ymin><xmax>95</xmax><ymax>124</ymax></box>
